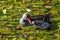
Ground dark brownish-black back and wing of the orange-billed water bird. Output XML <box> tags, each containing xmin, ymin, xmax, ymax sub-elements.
<box><xmin>31</xmin><ymin>13</ymin><xmax>51</xmax><ymax>24</ymax></box>
